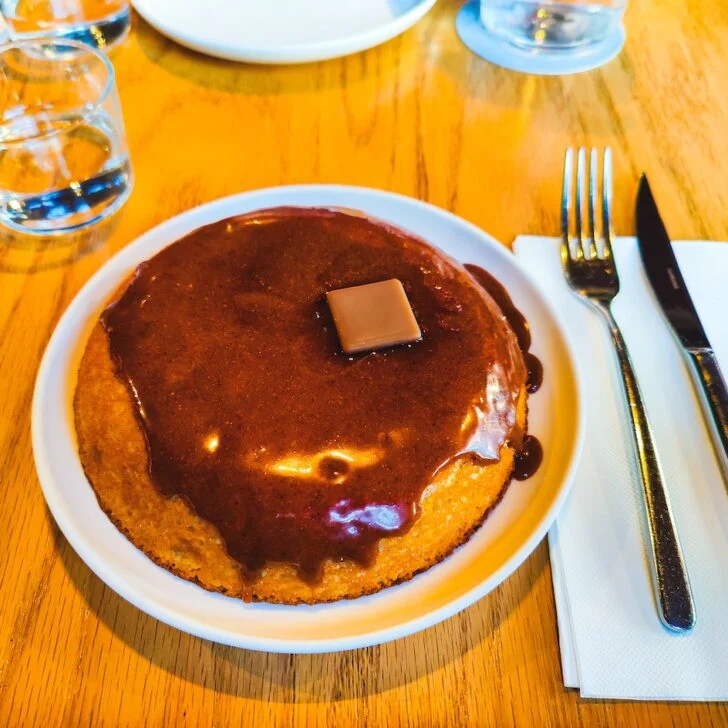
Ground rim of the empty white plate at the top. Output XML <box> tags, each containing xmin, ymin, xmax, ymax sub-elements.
<box><xmin>133</xmin><ymin>0</ymin><xmax>437</xmax><ymax>65</ymax></box>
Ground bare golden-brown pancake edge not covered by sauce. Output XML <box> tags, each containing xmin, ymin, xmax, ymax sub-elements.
<box><xmin>74</xmin><ymin>324</ymin><xmax>526</xmax><ymax>604</ymax></box>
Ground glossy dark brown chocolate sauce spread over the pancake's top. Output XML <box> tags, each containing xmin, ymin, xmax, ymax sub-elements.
<box><xmin>102</xmin><ymin>208</ymin><xmax>528</xmax><ymax>581</ymax></box>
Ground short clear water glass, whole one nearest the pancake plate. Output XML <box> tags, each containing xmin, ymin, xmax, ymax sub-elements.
<box><xmin>0</xmin><ymin>38</ymin><xmax>132</xmax><ymax>234</ymax></box>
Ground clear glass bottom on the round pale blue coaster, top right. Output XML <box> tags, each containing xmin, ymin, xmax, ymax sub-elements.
<box><xmin>480</xmin><ymin>0</ymin><xmax>627</xmax><ymax>51</ymax></box>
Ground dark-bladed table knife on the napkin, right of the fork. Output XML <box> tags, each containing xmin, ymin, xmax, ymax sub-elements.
<box><xmin>636</xmin><ymin>174</ymin><xmax>728</xmax><ymax>486</ymax></box>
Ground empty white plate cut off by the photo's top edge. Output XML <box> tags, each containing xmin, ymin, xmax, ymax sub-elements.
<box><xmin>134</xmin><ymin>0</ymin><xmax>435</xmax><ymax>63</ymax></box>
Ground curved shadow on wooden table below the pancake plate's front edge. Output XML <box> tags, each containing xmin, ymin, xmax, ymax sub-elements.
<box><xmin>46</xmin><ymin>504</ymin><xmax>548</xmax><ymax>703</ymax></box>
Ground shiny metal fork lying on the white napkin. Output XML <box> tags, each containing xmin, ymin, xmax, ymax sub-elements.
<box><xmin>561</xmin><ymin>147</ymin><xmax>695</xmax><ymax>632</ymax></box>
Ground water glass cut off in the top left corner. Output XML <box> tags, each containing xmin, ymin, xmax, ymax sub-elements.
<box><xmin>0</xmin><ymin>0</ymin><xmax>131</xmax><ymax>49</ymax></box>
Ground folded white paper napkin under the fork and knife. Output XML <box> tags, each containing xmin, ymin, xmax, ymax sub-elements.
<box><xmin>514</xmin><ymin>237</ymin><xmax>728</xmax><ymax>700</ymax></box>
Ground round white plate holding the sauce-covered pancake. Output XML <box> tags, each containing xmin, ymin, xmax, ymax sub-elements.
<box><xmin>32</xmin><ymin>185</ymin><xmax>583</xmax><ymax>652</ymax></box>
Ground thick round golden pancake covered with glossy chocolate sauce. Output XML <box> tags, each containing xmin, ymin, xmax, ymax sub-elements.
<box><xmin>74</xmin><ymin>208</ymin><xmax>527</xmax><ymax>604</ymax></box>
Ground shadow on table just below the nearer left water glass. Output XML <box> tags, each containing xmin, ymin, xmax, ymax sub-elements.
<box><xmin>0</xmin><ymin>215</ymin><xmax>119</xmax><ymax>275</ymax></box>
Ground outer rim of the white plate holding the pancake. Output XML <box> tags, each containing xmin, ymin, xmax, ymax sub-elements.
<box><xmin>31</xmin><ymin>184</ymin><xmax>585</xmax><ymax>654</ymax></box>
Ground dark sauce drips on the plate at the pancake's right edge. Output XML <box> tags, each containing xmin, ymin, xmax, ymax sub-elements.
<box><xmin>465</xmin><ymin>263</ymin><xmax>543</xmax><ymax>472</ymax></box>
